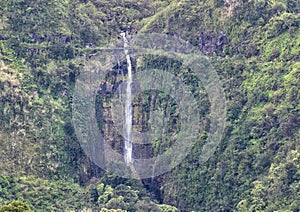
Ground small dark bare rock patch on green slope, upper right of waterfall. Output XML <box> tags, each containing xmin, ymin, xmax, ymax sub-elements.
<box><xmin>198</xmin><ymin>31</ymin><xmax>229</xmax><ymax>55</ymax></box>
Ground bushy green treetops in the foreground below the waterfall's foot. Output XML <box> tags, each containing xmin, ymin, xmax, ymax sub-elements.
<box><xmin>0</xmin><ymin>176</ymin><xmax>176</xmax><ymax>212</ymax></box>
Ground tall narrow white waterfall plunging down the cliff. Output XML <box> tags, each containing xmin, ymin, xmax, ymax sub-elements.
<box><xmin>121</xmin><ymin>32</ymin><xmax>133</xmax><ymax>164</ymax></box>
